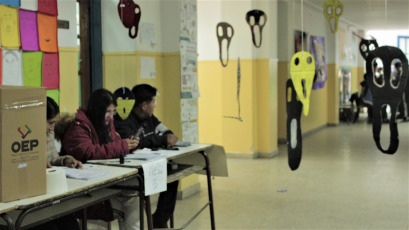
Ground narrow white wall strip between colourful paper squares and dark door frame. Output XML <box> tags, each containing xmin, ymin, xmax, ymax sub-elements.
<box><xmin>56</xmin><ymin>0</ymin><xmax>77</xmax><ymax>47</ymax></box>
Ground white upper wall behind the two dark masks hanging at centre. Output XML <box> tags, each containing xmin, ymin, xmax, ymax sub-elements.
<box><xmin>197</xmin><ymin>0</ymin><xmax>277</xmax><ymax>61</ymax></box>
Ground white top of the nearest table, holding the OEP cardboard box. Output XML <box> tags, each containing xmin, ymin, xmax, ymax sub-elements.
<box><xmin>0</xmin><ymin>164</ymin><xmax>138</xmax><ymax>208</ymax></box>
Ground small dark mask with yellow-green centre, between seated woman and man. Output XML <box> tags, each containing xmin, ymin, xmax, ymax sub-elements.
<box><xmin>114</xmin><ymin>87</ymin><xmax>135</xmax><ymax>120</ymax></box>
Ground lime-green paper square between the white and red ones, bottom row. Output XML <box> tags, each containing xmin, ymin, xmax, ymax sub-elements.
<box><xmin>23</xmin><ymin>52</ymin><xmax>43</xmax><ymax>87</ymax></box>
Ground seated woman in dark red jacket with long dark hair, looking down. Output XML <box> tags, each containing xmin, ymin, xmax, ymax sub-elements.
<box><xmin>61</xmin><ymin>89</ymin><xmax>139</xmax><ymax>230</ymax></box>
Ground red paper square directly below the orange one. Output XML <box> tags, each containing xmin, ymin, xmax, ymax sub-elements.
<box><xmin>42</xmin><ymin>53</ymin><xmax>60</xmax><ymax>89</ymax></box>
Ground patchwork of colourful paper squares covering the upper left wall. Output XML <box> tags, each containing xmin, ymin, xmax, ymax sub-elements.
<box><xmin>0</xmin><ymin>0</ymin><xmax>60</xmax><ymax>103</ymax></box>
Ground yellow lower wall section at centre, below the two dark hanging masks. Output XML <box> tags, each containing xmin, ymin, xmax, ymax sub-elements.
<box><xmin>198</xmin><ymin>59</ymin><xmax>277</xmax><ymax>158</ymax></box>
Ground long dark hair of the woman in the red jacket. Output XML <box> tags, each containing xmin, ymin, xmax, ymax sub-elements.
<box><xmin>87</xmin><ymin>89</ymin><xmax>117</xmax><ymax>144</ymax></box>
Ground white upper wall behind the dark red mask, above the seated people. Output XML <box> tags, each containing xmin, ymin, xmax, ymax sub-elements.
<box><xmin>101</xmin><ymin>0</ymin><xmax>180</xmax><ymax>52</ymax></box>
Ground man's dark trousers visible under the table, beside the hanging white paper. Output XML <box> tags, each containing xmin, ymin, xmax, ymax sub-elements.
<box><xmin>152</xmin><ymin>181</ymin><xmax>179</xmax><ymax>228</ymax></box>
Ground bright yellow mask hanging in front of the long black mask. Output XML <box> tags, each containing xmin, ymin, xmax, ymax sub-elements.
<box><xmin>290</xmin><ymin>51</ymin><xmax>315</xmax><ymax>116</ymax></box>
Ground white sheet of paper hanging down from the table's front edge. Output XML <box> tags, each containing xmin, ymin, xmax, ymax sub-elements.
<box><xmin>142</xmin><ymin>158</ymin><xmax>168</xmax><ymax>196</ymax></box>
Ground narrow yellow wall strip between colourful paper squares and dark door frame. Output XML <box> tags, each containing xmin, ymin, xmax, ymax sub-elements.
<box><xmin>59</xmin><ymin>47</ymin><xmax>79</xmax><ymax>113</ymax></box>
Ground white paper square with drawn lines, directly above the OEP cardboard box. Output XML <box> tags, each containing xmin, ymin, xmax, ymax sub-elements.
<box><xmin>2</xmin><ymin>49</ymin><xmax>23</xmax><ymax>86</ymax></box>
